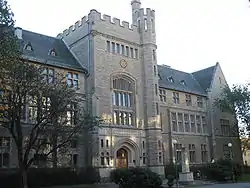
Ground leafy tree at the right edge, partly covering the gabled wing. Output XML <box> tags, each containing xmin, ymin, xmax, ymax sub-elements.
<box><xmin>215</xmin><ymin>84</ymin><xmax>250</xmax><ymax>151</ymax></box>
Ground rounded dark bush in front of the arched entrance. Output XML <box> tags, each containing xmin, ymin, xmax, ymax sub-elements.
<box><xmin>110</xmin><ymin>168</ymin><xmax>162</xmax><ymax>188</ymax></box>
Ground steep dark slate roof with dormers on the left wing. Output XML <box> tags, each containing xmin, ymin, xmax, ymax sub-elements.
<box><xmin>21</xmin><ymin>30</ymin><xmax>86</xmax><ymax>72</ymax></box>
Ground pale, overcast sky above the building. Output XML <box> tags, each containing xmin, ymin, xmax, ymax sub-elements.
<box><xmin>8</xmin><ymin>0</ymin><xmax>250</xmax><ymax>85</ymax></box>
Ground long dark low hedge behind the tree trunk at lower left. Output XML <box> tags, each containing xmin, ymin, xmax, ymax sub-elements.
<box><xmin>0</xmin><ymin>167</ymin><xmax>100</xmax><ymax>188</ymax></box>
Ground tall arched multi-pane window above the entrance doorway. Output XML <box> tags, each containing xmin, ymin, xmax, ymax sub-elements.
<box><xmin>112</xmin><ymin>77</ymin><xmax>135</xmax><ymax>125</ymax></box>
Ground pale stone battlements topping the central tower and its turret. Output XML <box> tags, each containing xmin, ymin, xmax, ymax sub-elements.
<box><xmin>57</xmin><ymin>8</ymin><xmax>155</xmax><ymax>38</ymax></box>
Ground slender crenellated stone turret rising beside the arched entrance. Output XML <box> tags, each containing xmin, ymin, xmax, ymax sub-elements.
<box><xmin>131</xmin><ymin>0</ymin><xmax>164</xmax><ymax>174</ymax></box>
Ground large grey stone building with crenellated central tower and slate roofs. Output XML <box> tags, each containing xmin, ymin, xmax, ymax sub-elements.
<box><xmin>0</xmin><ymin>0</ymin><xmax>241</xmax><ymax>177</ymax></box>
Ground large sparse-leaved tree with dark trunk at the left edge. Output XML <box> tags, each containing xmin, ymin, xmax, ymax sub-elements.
<box><xmin>0</xmin><ymin>0</ymin><xmax>100</xmax><ymax>188</ymax></box>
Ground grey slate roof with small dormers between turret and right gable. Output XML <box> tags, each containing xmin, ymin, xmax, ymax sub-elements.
<box><xmin>158</xmin><ymin>65</ymin><xmax>206</xmax><ymax>96</ymax></box>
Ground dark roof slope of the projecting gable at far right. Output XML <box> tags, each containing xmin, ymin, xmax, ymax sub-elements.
<box><xmin>192</xmin><ymin>63</ymin><xmax>218</xmax><ymax>91</ymax></box>
